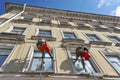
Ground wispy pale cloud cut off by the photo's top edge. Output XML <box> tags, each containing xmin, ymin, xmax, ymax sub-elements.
<box><xmin>97</xmin><ymin>0</ymin><xmax>120</xmax><ymax>8</ymax></box>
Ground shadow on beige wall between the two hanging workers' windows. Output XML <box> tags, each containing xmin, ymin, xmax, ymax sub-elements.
<box><xmin>60</xmin><ymin>58</ymin><xmax>74</xmax><ymax>73</ymax></box>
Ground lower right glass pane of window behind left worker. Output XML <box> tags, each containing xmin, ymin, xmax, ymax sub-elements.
<box><xmin>44</xmin><ymin>58</ymin><xmax>53</xmax><ymax>71</ymax></box>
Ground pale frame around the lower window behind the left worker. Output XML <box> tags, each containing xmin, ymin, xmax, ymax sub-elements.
<box><xmin>22</xmin><ymin>46</ymin><xmax>57</xmax><ymax>73</ymax></box>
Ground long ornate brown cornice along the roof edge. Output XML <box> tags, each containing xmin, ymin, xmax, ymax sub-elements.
<box><xmin>6</xmin><ymin>3</ymin><xmax>120</xmax><ymax>23</ymax></box>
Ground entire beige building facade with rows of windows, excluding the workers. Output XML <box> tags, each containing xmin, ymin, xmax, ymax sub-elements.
<box><xmin>0</xmin><ymin>3</ymin><xmax>120</xmax><ymax>80</ymax></box>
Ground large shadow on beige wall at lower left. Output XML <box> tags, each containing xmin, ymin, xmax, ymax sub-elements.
<box><xmin>4</xmin><ymin>59</ymin><xmax>24</xmax><ymax>72</ymax></box>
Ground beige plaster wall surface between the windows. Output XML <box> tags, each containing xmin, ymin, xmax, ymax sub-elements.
<box><xmin>0</xmin><ymin>10</ymin><xmax>120</xmax><ymax>75</ymax></box>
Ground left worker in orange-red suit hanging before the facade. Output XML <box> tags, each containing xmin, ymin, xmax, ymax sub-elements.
<box><xmin>36</xmin><ymin>40</ymin><xmax>53</xmax><ymax>59</ymax></box>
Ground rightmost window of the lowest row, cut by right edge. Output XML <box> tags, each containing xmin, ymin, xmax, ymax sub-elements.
<box><xmin>107</xmin><ymin>55</ymin><xmax>120</xmax><ymax>72</ymax></box>
